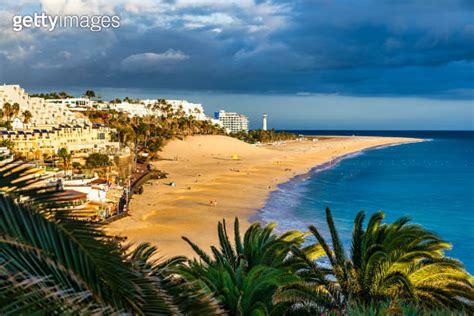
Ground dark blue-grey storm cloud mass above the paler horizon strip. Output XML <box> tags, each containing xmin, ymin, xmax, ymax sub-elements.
<box><xmin>0</xmin><ymin>0</ymin><xmax>474</xmax><ymax>98</ymax></box>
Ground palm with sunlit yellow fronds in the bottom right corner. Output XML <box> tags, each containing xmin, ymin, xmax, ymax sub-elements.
<box><xmin>274</xmin><ymin>209</ymin><xmax>474</xmax><ymax>313</ymax></box>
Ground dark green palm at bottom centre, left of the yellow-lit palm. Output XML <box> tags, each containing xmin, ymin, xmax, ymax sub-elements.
<box><xmin>181</xmin><ymin>219</ymin><xmax>314</xmax><ymax>315</ymax></box>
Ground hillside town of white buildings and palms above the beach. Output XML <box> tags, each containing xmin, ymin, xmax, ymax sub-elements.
<box><xmin>0</xmin><ymin>84</ymin><xmax>252</xmax><ymax>221</ymax></box>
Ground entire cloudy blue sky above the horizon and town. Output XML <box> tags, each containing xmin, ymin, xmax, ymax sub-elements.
<box><xmin>0</xmin><ymin>0</ymin><xmax>474</xmax><ymax>130</ymax></box>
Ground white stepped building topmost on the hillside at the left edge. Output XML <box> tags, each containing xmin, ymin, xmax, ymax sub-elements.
<box><xmin>0</xmin><ymin>84</ymin><xmax>89</xmax><ymax>129</ymax></box>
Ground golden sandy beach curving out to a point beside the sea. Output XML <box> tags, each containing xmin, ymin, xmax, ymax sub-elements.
<box><xmin>107</xmin><ymin>136</ymin><xmax>419</xmax><ymax>256</ymax></box>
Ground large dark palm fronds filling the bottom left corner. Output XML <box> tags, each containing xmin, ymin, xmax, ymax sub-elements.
<box><xmin>0</xmin><ymin>161</ymin><xmax>222</xmax><ymax>315</ymax></box>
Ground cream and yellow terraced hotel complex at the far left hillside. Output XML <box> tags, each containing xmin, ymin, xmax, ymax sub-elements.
<box><xmin>0</xmin><ymin>85</ymin><xmax>120</xmax><ymax>159</ymax></box>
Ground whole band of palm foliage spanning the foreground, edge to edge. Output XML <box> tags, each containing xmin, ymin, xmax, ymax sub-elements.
<box><xmin>0</xmin><ymin>160</ymin><xmax>474</xmax><ymax>315</ymax></box>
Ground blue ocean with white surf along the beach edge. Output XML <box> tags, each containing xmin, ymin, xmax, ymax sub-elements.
<box><xmin>257</xmin><ymin>131</ymin><xmax>474</xmax><ymax>273</ymax></box>
